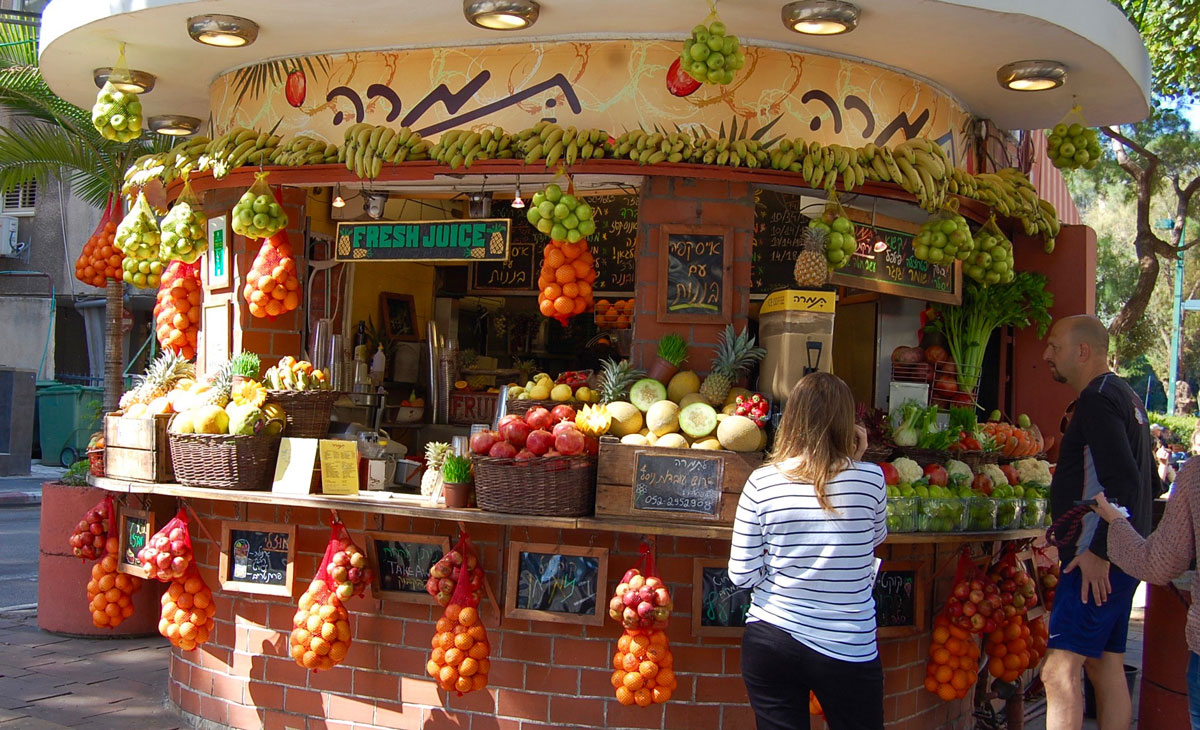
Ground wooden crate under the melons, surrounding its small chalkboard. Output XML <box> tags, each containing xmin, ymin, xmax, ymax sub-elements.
<box><xmin>596</xmin><ymin>436</ymin><xmax>763</xmax><ymax>525</ymax></box>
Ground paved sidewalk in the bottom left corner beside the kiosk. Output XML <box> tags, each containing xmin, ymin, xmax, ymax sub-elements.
<box><xmin>0</xmin><ymin>611</ymin><xmax>180</xmax><ymax>730</ymax></box>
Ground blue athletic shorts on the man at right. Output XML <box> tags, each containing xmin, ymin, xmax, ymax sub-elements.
<box><xmin>1046</xmin><ymin>566</ymin><xmax>1140</xmax><ymax>659</ymax></box>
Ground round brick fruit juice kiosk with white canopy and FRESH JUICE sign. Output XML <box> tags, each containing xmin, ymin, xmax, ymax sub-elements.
<box><xmin>41</xmin><ymin>0</ymin><xmax>1148</xmax><ymax>729</ymax></box>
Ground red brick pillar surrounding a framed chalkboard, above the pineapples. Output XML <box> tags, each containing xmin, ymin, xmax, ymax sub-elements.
<box><xmin>631</xmin><ymin>176</ymin><xmax>754</xmax><ymax>373</ymax></box>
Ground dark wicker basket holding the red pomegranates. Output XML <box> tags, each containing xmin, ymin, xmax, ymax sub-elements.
<box><xmin>472</xmin><ymin>455</ymin><xmax>596</xmax><ymax>517</ymax></box>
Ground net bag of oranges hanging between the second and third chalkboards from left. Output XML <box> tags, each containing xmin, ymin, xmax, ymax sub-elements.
<box><xmin>288</xmin><ymin>520</ymin><xmax>361</xmax><ymax>671</ymax></box>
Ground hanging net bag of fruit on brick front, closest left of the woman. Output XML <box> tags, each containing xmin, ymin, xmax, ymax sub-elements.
<box><xmin>608</xmin><ymin>544</ymin><xmax>677</xmax><ymax>707</ymax></box>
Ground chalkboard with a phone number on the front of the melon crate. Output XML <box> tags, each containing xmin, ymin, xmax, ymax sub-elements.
<box><xmin>632</xmin><ymin>451</ymin><xmax>725</xmax><ymax>517</ymax></box>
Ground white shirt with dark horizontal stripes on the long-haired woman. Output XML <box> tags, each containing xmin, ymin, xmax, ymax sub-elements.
<box><xmin>728</xmin><ymin>461</ymin><xmax>888</xmax><ymax>662</ymax></box>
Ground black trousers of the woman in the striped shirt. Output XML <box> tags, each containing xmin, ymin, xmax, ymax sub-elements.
<box><xmin>742</xmin><ymin>621</ymin><xmax>883</xmax><ymax>730</ymax></box>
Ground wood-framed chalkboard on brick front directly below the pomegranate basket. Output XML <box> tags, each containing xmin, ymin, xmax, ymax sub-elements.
<box><xmin>504</xmin><ymin>540</ymin><xmax>608</xmax><ymax>626</ymax></box>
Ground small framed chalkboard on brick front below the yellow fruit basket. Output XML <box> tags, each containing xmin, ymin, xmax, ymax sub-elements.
<box><xmin>218</xmin><ymin>522</ymin><xmax>296</xmax><ymax>597</ymax></box>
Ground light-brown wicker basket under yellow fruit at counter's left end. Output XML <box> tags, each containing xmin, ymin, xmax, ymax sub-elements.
<box><xmin>168</xmin><ymin>433</ymin><xmax>280</xmax><ymax>490</ymax></box>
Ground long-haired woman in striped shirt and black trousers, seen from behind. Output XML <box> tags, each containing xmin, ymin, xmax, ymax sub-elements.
<box><xmin>728</xmin><ymin>372</ymin><xmax>887</xmax><ymax>730</ymax></box>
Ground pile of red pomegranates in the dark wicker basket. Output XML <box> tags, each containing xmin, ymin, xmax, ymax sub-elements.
<box><xmin>470</xmin><ymin>403</ymin><xmax>600</xmax><ymax>461</ymax></box>
